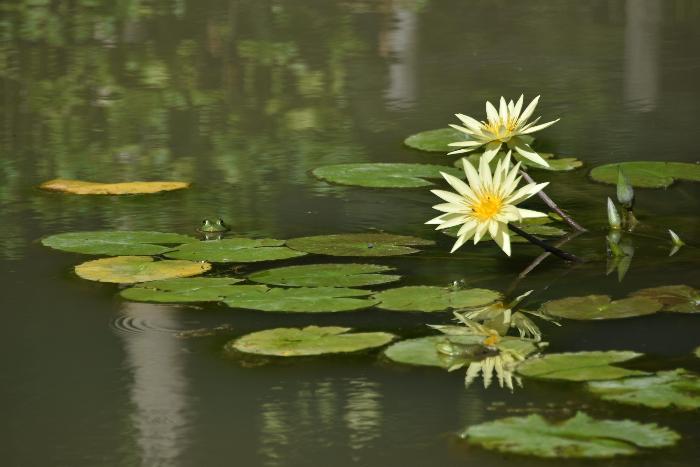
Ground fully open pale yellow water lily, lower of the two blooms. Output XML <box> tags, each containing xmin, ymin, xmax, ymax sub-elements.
<box><xmin>426</xmin><ymin>151</ymin><xmax>547</xmax><ymax>256</ymax></box>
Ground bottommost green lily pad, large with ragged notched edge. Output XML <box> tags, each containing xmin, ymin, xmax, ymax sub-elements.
<box><xmin>460</xmin><ymin>412</ymin><xmax>680</xmax><ymax>459</ymax></box>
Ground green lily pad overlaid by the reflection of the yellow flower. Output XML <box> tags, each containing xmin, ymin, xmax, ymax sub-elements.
<box><xmin>384</xmin><ymin>334</ymin><xmax>537</xmax><ymax>369</ymax></box>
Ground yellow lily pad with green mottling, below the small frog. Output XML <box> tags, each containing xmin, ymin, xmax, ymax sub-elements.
<box><xmin>75</xmin><ymin>256</ymin><xmax>211</xmax><ymax>284</ymax></box>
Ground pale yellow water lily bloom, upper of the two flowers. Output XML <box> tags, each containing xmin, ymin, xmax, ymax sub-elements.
<box><xmin>449</xmin><ymin>95</ymin><xmax>559</xmax><ymax>167</ymax></box>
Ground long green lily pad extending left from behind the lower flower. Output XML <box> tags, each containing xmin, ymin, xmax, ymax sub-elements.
<box><xmin>312</xmin><ymin>163</ymin><xmax>464</xmax><ymax>188</ymax></box>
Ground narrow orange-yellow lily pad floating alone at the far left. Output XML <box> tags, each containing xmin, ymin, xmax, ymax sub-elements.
<box><xmin>39</xmin><ymin>178</ymin><xmax>190</xmax><ymax>195</ymax></box>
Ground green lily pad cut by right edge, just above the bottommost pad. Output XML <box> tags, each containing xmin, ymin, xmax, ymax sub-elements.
<box><xmin>586</xmin><ymin>369</ymin><xmax>700</xmax><ymax>410</ymax></box>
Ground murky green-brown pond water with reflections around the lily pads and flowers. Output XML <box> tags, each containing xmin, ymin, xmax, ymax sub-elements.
<box><xmin>0</xmin><ymin>0</ymin><xmax>700</xmax><ymax>467</ymax></box>
